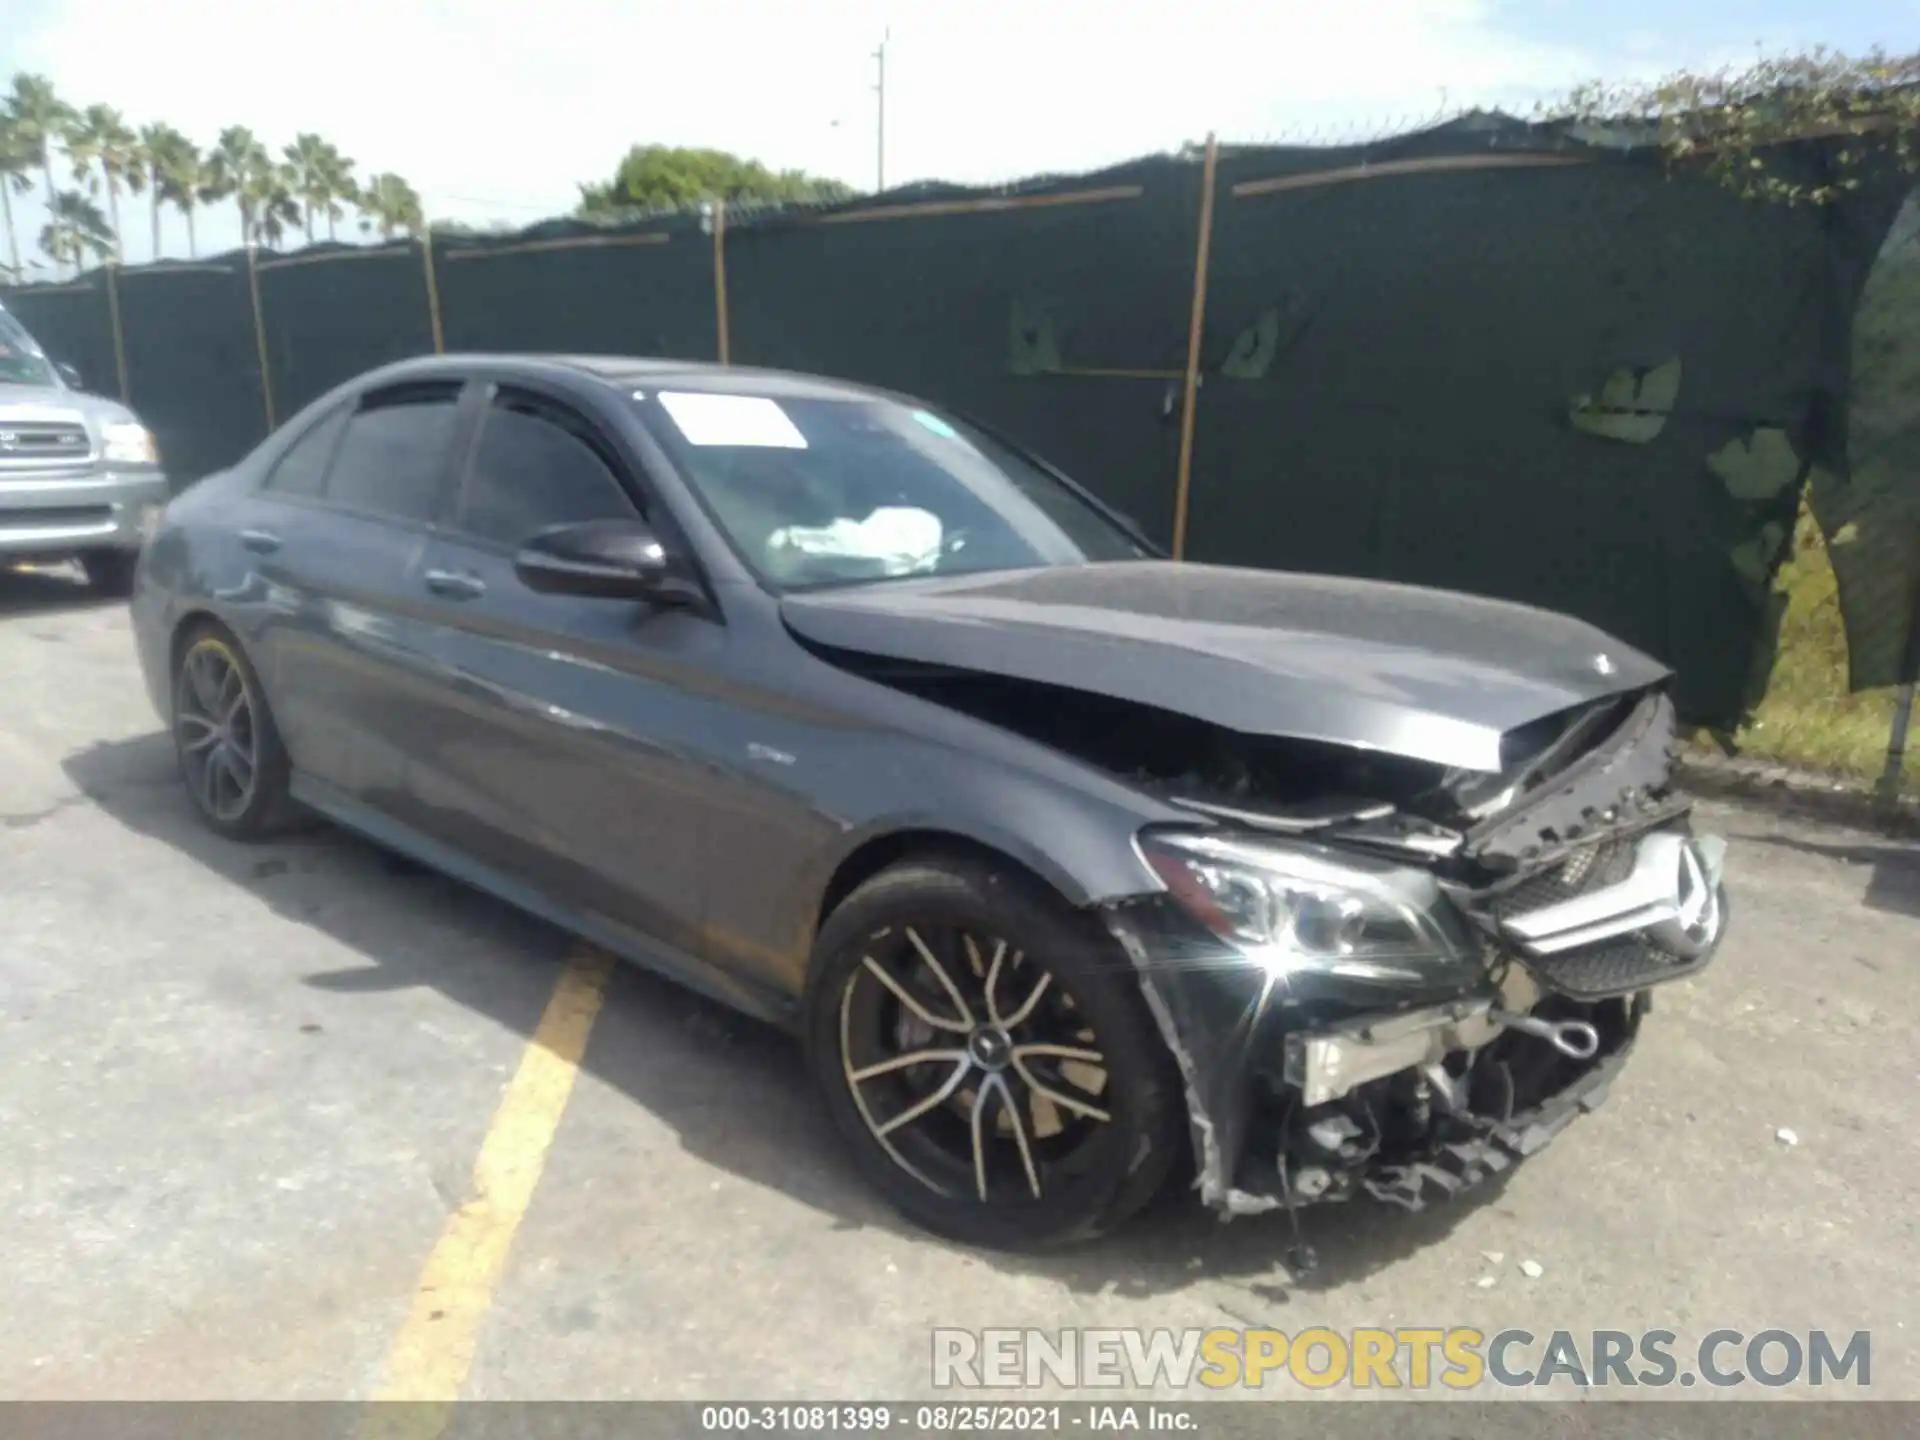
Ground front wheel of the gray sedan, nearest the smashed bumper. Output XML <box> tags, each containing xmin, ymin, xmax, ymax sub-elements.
<box><xmin>806</xmin><ymin>858</ymin><xmax>1187</xmax><ymax>1250</ymax></box>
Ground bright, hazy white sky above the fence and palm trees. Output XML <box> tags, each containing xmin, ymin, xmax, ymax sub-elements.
<box><xmin>0</xmin><ymin>0</ymin><xmax>1920</xmax><ymax>263</ymax></box>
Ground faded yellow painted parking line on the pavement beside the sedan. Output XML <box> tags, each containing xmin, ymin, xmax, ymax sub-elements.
<box><xmin>367</xmin><ymin>948</ymin><xmax>612</xmax><ymax>1440</ymax></box>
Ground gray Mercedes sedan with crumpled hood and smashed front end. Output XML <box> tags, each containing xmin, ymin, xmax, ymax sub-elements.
<box><xmin>132</xmin><ymin>355</ymin><xmax>1726</xmax><ymax>1246</ymax></box>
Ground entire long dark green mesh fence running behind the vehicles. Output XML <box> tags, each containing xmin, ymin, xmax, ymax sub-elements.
<box><xmin>8</xmin><ymin>117</ymin><xmax>1920</xmax><ymax>726</ymax></box>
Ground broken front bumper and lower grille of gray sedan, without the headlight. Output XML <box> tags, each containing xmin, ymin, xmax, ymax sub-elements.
<box><xmin>1106</xmin><ymin>806</ymin><xmax>1726</xmax><ymax>1215</ymax></box>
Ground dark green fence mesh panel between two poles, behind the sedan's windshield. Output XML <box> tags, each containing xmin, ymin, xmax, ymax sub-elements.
<box><xmin>726</xmin><ymin>159</ymin><xmax>1200</xmax><ymax>541</ymax></box>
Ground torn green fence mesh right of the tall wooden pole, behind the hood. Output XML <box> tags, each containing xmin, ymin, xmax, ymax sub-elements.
<box><xmin>1190</xmin><ymin>139</ymin><xmax>1830</xmax><ymax>716</ymax></box>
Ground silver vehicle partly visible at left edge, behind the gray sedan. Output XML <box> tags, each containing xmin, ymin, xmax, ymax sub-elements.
<box><xmin>0</xmin><ymin>305</ymin><xmax>167</xmax><ymax>595</ymax></box>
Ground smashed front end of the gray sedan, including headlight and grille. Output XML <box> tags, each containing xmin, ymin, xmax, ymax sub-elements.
<box><xmin>1104</xmin><ymin>687</ymin><xmax>1726</xmax><ymax>1213</ymax></box>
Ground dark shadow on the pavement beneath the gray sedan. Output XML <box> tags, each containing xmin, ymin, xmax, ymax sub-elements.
<box><xmin>63</xmin><ymin>733</ymin><xmax>1500</xmax><ymax>1321</ymax></box>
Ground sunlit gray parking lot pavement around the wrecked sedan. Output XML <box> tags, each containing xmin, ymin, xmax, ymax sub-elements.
<box><xmin>0</xmin><ymin>574</ymin><xmax>1920</xmax><ymax>1400</ymax></box>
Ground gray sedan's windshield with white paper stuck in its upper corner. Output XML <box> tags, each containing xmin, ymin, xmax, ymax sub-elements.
<box><xmin>636</xmin><ymin>390</ymin><xmax>1148</xmax><ymax>589</ymax></box>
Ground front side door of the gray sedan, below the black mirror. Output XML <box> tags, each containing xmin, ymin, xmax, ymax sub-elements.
<box><xmin>407</xmin><ymin>386</ymin><xmax>724</xmax><ymax>971</ymax></box>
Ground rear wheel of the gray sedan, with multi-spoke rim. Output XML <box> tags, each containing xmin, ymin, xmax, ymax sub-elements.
<box><xmin>173</xmin><ymin>624</ymin><xmax>294</xmax><ymax>841</ymax></box>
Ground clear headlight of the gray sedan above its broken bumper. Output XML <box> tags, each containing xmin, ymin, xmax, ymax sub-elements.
<box><xmin>1140</xmin><ymin>831</ymin><xmax>1467</xmax><ymax>979</ymax></box>
